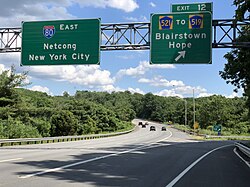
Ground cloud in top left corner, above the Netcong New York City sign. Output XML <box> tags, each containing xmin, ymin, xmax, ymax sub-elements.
<box><xmin>0</xmin><ymin>0</ymin><xmax>76</xmax><ymax>27</ymax></box>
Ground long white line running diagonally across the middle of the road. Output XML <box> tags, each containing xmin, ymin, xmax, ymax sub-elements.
<box><xmin>19</xmin><ymin>130</ymin><xmax>172</xmax><ymax>179</ymax></box>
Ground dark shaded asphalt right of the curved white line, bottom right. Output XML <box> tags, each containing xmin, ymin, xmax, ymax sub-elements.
<box><xmin>175</xmin><ymin>146</ymin><xmax>250</xmax><ymax>187</ymax></box>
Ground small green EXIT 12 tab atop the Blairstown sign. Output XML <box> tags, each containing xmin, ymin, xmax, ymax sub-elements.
<box><xmin>171</xmin><ymin>3</ymin><xmax>213</xmax><ymax>13</ymax></box>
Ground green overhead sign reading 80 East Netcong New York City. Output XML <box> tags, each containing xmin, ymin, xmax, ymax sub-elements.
<box><xmin>21</xmin><ymin>19</ymin><xmax>100</xmax><ymax>66</ymax></box>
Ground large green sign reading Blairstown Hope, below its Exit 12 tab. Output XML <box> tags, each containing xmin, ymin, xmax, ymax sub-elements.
<box><xmin>150</xmin><ymin>12</ymin><xmax>212</xmax><ymax>64</ymax></box>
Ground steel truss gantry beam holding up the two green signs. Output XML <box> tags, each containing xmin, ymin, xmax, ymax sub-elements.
<box><xmin>0</xmin><ymin>19</ymin><xmax>250</xmax><ymax>53</ymax></box>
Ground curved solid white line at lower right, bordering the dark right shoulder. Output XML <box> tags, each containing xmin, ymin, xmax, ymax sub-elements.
<box><xmin>166</xmin><ymin>144</ymin><xmax>233</xmax><ymax>187</ymax></box>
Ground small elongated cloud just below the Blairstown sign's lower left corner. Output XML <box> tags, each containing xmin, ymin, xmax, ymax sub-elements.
<box><xmin>116</xmin><ymin>61</ymin><xmax>175</xmax><ymax>78</ymax></box>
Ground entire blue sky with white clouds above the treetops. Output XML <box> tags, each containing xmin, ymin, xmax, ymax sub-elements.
<box><xmin>0</xmin><ymin>0</ymin><xmax>242</xmax><ymax>98</ymax></box>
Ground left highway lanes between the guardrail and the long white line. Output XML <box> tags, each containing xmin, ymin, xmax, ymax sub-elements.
<box><xmin>0</xmin><ymin>120</ymin><xmax>170</xmax><ymax>186</ymax></box>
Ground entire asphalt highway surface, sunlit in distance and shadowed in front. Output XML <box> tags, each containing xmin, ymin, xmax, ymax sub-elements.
<box><xmin>0</xmin><ymin>120</ymin><xmax>250</xmax><ymax>187</ymax></box>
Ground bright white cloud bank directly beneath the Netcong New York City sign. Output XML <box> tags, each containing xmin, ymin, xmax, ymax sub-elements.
<box><xmin>0</xmin><ymin>53</ymin><xmax>114</xmax><ymax>88</ymax></box>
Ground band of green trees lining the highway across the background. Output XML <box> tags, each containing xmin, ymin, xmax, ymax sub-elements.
<box><xmin>0</xmin><ymin>67</ymin><xmax>250</xmax><ymax>138</ymax></box>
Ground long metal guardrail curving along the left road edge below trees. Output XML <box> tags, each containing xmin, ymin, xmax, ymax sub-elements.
<box><xmin>0</xmin><ymin>128</ymin><xmax>135</xmax><ymax>147</ymax></box>
